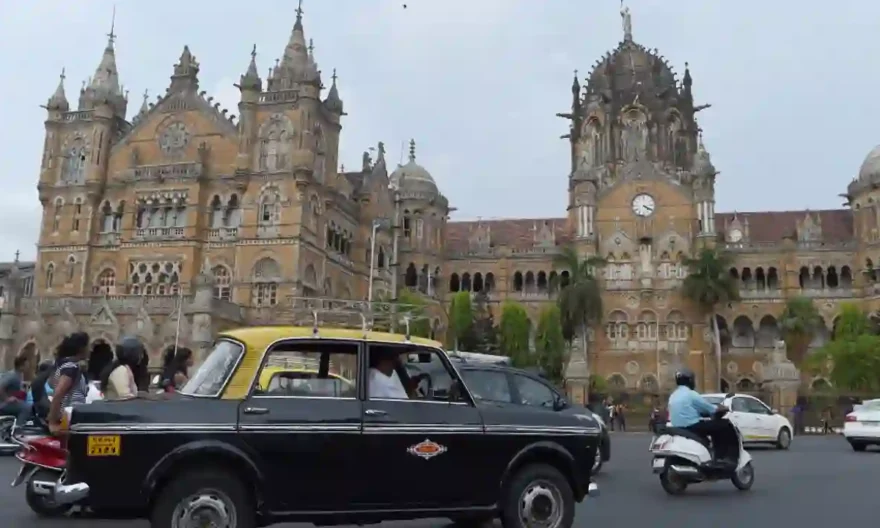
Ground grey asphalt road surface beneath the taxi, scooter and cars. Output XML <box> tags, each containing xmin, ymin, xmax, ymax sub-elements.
<box><xmin>0</xmin><ymin>433</ymin><xmax>880</xmax><ymax>528</ymax></box>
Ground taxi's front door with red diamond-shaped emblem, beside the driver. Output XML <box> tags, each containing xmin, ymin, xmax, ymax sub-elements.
<box><xmin>358</xmin><ymin>343</ymin><xmax>485</xmax><ymax>509</ymax></box>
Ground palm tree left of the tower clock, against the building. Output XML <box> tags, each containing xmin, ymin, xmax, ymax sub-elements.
<box><xmin>554</xmin><ymin>246</ymin><xmax>605</xmax><ymax>379</ymax></box>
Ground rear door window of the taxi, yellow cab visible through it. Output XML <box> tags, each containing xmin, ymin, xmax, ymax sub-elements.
<box><xmin>254</xmin><ymin>340</ymin><xmax>359</xmax><ymax>398</ymax></box>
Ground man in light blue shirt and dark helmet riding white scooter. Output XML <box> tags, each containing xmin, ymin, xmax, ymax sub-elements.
<box><xmin>668</xmin><ymin>368</ymin><xmax>736</xmax><ymax>463</ymax></box>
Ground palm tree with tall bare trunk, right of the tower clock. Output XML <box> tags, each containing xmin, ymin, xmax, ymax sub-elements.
<box><xmin>681</xmin><ymin>248</ymin><xmax>739</xmax><ymax>388</ymax></box>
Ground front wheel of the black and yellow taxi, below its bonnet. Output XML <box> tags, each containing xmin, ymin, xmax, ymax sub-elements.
<box><xmin>501</xmin><ymin>464</ymin><xmax>575</xmax><ymax>528</ymax></box>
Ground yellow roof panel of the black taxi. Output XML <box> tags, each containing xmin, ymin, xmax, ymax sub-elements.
<box><xmin>219</xmin><ymin>326</ymin><xmax>443</xmax><ymax>350</ymax></box>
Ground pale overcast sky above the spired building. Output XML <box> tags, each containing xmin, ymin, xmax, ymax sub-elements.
<box><xmin>0</xmin><ymin>0</ymin><xmax>880</xmax><ymax>260</ymax></box>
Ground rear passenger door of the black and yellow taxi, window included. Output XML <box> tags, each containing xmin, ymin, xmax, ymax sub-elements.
<box><xmin>238</xmin><ymin>338</ymin><xmax>362</xmax><ymax>512</ymax></box>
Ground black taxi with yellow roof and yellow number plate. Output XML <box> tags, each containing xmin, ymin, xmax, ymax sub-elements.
<box><xmin>36</xmin><ymin>327</ymin><xmax>601</xmax><ymax>528</ymax></box>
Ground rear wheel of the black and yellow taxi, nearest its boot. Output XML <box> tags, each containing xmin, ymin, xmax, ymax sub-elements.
<box><xmin>150</xmin><ymin>469</ymin><xmax>257</xmax><ymax>528</ymax></box>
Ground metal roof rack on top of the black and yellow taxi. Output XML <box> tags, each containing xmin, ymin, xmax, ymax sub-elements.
<box><xmin>284</xmin><ymin>297</ymin><xmax>431</xmax><ymax>341</ymax></box>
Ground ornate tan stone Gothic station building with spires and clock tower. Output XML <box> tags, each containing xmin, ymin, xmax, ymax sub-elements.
<box><xmin>0</xmin><ymin>6</ymin><xmax>880</xmax><ymax>390</ymax></box>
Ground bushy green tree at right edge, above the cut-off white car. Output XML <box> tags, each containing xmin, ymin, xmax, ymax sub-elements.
<box><xmin>805</xmin><ymin>303</ymin><xmax>880</xmax><ymax>392</ymax></box>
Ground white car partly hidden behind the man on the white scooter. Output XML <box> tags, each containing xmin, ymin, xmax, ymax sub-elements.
<box><xmin>667</xmin><ymin>394</ymin><xmax>796</xmax><ymax>449</ymax></box>
